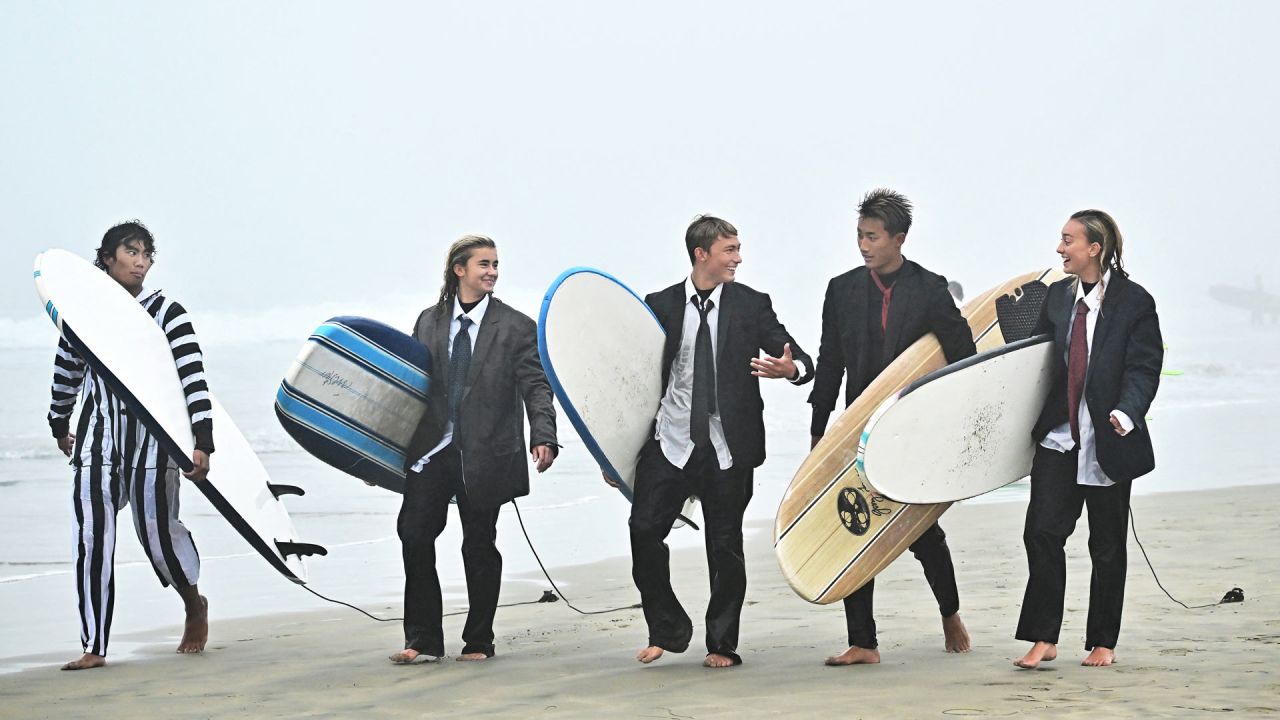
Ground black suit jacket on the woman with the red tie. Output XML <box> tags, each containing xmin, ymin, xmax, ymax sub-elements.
<box><xmin>1032</xmin><ymin>272</ymin><xmax>1165</xmax><ymax>483</ymax></box>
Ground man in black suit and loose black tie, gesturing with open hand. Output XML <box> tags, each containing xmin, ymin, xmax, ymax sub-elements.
<box><xmin>630</xmin><ymin>215</ymin><xmax>813</xmax><ymax>667</ymax></box>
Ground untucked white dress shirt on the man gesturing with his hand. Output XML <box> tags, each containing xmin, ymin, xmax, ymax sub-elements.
<box><xmin>654</xmin><ymin>275</ymin><xmax>808</xmax><ymax>470</ymax></box>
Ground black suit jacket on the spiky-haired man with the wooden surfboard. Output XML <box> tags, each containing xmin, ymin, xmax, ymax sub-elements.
<box><xmin>809</xmin><ymin>260</ymin><xmax>975</xmax><ymax>434</ymax></box>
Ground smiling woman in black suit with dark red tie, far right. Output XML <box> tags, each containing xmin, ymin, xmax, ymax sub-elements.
<box><xmin>1014</xmin><ymin>210</ymin><xmax>1165</xmax><ymax>669</ymax></box>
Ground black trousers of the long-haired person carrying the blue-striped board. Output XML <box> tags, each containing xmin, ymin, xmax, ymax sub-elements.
<box><xmin>396</xmin><ymin>445</ymin><xmax>502</xmax><ymax>657</ymax></box>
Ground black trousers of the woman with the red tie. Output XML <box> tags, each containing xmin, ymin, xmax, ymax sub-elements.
<box><xmin>1015</xmin><ymin>447</ymin><xmax>1132</xmax><ymax>650</ymax></box>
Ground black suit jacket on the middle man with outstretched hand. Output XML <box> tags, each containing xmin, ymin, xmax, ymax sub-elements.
<box><xmin>644</xmin><ymin>281</ymin><xmax>813</xmax><ymax>468</ymax></box>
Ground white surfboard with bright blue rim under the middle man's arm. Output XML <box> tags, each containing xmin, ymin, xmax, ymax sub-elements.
<box><xmin>538</xmin><ymin>268</ymin><xmax>694</xmax><ymax>519</ymax></box>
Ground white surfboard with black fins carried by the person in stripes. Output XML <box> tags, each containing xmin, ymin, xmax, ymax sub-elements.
<box><xmin>35</xmin><ymin>250</ymin><xmax>318</xmax><ymax>584</ymax></box>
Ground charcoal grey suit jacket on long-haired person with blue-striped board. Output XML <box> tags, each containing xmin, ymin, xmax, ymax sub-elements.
<box><xmin>404</xmin><ymin>295</ymin><xmax>558</xmax><ymax>507</ymax></box>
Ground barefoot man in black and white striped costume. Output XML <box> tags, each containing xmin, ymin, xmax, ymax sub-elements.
<box><xmin>49</xmin><ymin>222</ymin><xmax>214</xmax><ymax>670</ymax></box>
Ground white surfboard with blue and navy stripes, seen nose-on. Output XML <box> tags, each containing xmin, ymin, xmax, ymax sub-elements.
<box><xmin>275</xmin><ymin>316</ymin><xmax>431</xmax><ymax>492</ymax></box>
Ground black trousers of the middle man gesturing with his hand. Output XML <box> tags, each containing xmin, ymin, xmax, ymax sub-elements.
<box><xmin>630</xmin><ymin>439</ymin><xmax>753</xmax><ymax>664</ymax></box>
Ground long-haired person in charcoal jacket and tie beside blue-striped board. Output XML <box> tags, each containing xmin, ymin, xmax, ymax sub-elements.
<box><xmin>390</xmin><ymin>236</ymin><xmax>559</xmax><ymax>664</ymax></box>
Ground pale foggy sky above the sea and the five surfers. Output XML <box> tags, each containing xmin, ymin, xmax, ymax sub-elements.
<box><xmin>0</xmin><ymin>1</ymin><xmax>1280</xmax><ymax>350</ymax></box>
